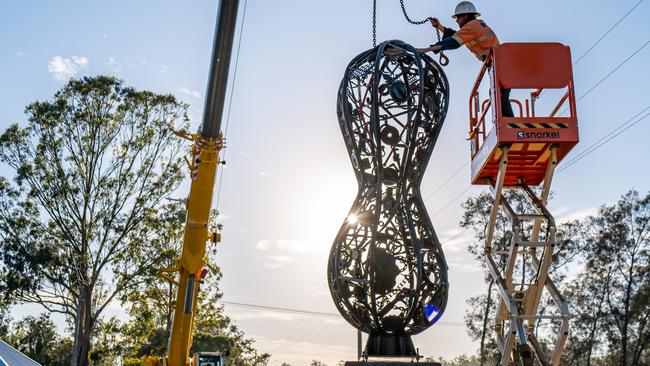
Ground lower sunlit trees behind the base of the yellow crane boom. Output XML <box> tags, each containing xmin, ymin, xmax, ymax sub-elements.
<box><xmin>114</xmin><ymin>205</ymin><xmax>270</xmax><ymax>366</ymax></box>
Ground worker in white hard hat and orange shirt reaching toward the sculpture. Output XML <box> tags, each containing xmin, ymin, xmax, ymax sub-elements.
<box><xmin>418</xmin><ymin>1</ymin><xmax>514</xmax><ymax>117</ymax></box>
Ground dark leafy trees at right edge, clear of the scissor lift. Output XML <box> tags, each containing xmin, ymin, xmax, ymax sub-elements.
<box><xmin>564</xmin><ymin>190</ymin><xmax>650</xmax><ymax>366</ymax></box>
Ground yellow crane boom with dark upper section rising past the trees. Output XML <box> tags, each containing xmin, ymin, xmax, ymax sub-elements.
<box><xmin>145</xmin><ymin>0</ymin><xmax>239</xmax><ymax>366</ymax></box>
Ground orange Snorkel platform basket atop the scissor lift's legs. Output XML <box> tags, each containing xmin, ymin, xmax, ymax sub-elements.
<box><xmin>469</xmin><ymin>43</ymin><xmax>578</xmax><ymax>186</ymax></box>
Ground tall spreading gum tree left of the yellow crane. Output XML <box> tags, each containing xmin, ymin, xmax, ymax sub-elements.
<box><xmin>0</xmin><ymin>76</ymin><xmax>187</xmax><ymax>365</ymax></box>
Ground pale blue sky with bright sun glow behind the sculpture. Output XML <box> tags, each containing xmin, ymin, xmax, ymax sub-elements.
<box><xmin>0</xmin><ymin>0</ymin><xmax>650</xmax><ymax>364</ymax></box>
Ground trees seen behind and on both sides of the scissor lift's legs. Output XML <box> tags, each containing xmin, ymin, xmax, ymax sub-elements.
<box><xmin>461</xmin><ymin>187</ymin><xmax>650</xmax><ymax>366</ymax></box>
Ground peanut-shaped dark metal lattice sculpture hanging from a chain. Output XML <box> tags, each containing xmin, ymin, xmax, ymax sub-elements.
<box><xmin>328</xmin><ymin>41</ymin><xmax>449</xmax><ymax>356</ymax></box>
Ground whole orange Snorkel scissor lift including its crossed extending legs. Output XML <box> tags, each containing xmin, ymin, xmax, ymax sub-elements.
<box><xmin>469</xmin><ymin>43</ymin><xmax>578</xmax><ymax>366</ymax></box>
